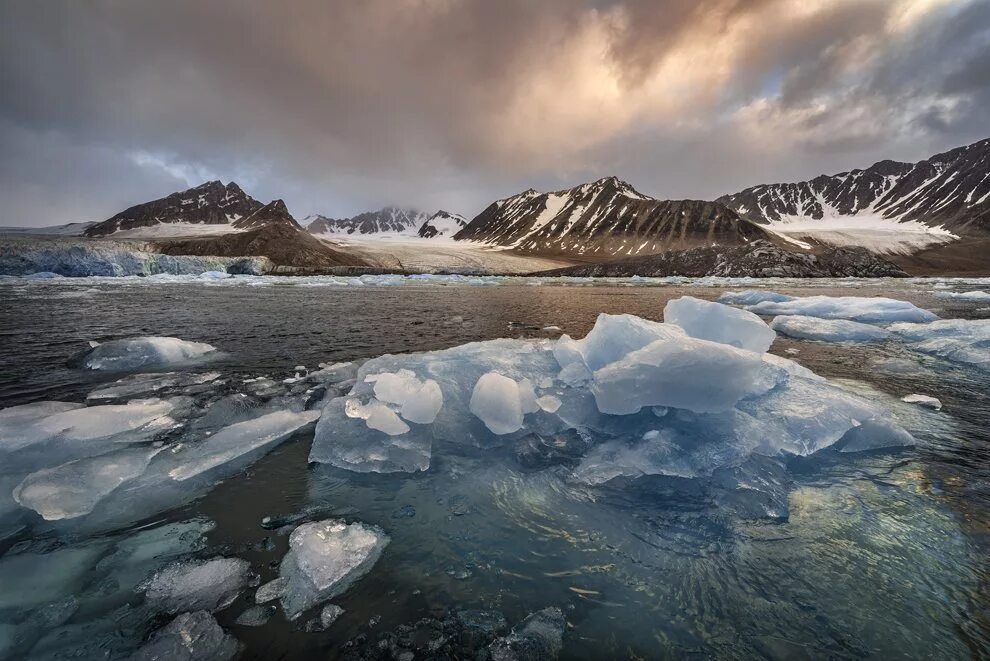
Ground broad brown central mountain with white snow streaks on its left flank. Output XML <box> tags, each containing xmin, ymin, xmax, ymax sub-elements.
<box><xmin>454</xmin><ymin>177</ymin><xmax>769</xmax><ymax>257</ymax></box>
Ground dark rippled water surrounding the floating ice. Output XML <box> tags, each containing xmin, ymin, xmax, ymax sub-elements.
<box><xmin>0</xmin><ymin>282</ymin><xmax>990</xmax><ymax>659</ymax></box>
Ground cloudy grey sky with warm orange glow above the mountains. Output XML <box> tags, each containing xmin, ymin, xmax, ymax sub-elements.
<box><xmin>0</xmin><ymin>0</ymin><xmax>990</xmax><ymax>226</ymax></box>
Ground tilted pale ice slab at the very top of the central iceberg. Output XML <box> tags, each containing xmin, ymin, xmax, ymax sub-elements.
<box><xmin>663</xmin><ymin>296</ymin><xmax>777</xmax><ymax>353</ymax></box>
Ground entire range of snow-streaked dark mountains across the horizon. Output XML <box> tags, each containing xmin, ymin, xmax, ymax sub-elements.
<box><xmin>9</xmin><ymin>139</ymin><xmax>990</xmax><ymax>272</ymax></box>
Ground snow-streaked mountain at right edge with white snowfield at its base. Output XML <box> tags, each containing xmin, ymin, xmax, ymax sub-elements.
<box><xmin>717</xmin><ymin>139</ymin><xmax>990</xmax><ymax>235</ymax></box>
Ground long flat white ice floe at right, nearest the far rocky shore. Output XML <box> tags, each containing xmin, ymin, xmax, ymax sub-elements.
<box><xmin>746</xmin><ymin>296</ymin><xmax>938</xmax><ymax>324</ymax></box>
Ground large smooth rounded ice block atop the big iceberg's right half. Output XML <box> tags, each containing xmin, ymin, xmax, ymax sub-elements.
<box><xmin>591</xmin><ymin>335</ymin><xmax>768</xmax><ymax>415</ymax></box>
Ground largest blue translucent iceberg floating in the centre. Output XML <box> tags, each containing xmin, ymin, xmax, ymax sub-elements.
<box><xmin>310</xmin><ymin>304</ymin><xmax>916</xmax><ymax>484</ymax></box>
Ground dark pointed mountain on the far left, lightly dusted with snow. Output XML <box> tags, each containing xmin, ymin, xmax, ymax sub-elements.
<box><xmin>85</xmin><ymin>181</ymin><xmax>264</xmax><ymax>236</ymax></box>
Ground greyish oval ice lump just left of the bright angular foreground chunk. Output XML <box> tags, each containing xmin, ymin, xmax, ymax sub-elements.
<box><xmin>141</xmin><ymin>558</ymin><xmax>251</xmax><ymax>614</ymax></box>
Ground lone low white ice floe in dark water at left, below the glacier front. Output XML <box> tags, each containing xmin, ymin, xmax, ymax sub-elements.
<box><xmin>69</xmin><ymin>337</ymin><xmax>218</xmax><ymax>372</ymax></box>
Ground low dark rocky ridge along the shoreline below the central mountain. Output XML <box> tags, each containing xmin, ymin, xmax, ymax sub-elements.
<box><xmin>537</xmin><ymin>241</ymin><xmax>908</xmax><ymax>278</ymax></box>
